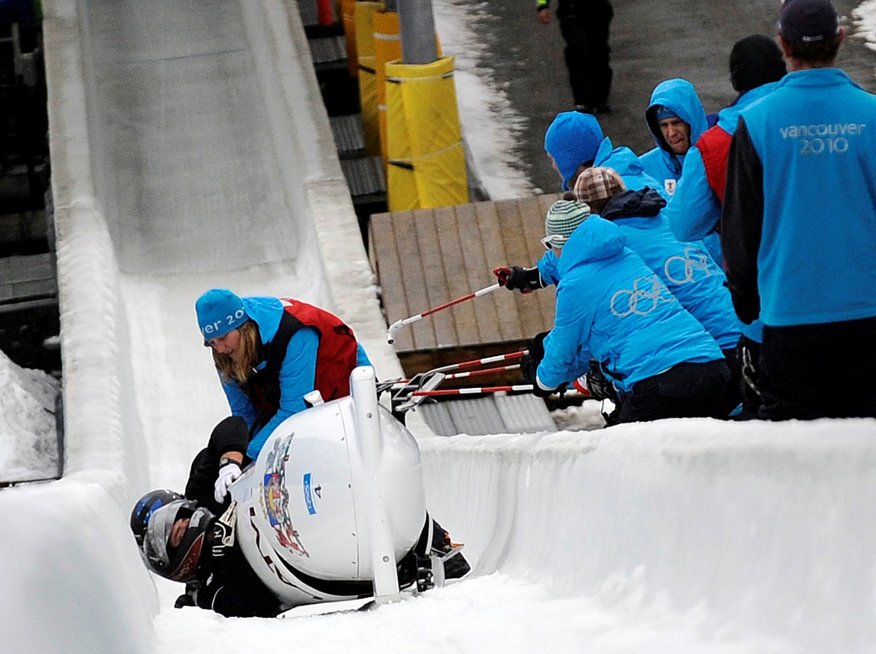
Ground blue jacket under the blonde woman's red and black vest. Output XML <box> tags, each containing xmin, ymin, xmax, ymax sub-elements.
<box><xmin>222</xmin><ymin>297</ymin><xmax>371</xmax><ymax>459</ymax></box>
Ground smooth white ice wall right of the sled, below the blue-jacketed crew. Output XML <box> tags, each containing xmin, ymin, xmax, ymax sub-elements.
<box><xmin>421</xmin><ymin>420</ymin><xmax>876</xmax><ymax>652</ymax></box>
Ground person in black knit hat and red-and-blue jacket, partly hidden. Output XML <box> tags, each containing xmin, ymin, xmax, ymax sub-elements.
<box><xmin>663</xmin><ymin>34</ymin><xmax>787</xmax><ymax>418</ymax></box>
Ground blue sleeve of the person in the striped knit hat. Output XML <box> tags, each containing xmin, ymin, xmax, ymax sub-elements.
<box><xmin>536</xmin><ymin>287</ymin><xmax>592</xmax><ymax>388</ymax></box>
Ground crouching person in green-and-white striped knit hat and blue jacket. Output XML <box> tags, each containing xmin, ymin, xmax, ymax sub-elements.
<box><xmin>532</xmin><ymin>200</ymin><xmax>730</xmax><ymax>422</ymax></box>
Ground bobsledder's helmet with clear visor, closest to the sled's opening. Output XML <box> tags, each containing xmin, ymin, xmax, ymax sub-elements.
<box><xmin>140</xmin><ymin>499</ymin><xmax>215</xmax><ymax>582</ymax></box>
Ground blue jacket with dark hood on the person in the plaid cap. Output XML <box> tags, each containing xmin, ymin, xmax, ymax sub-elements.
<box><xmin>601</xmin><ymin>189</ymin><xmax>742</xmax><ymax>350</ymax></box>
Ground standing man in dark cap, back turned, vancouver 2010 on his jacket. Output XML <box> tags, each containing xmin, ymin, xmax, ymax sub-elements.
<box><xmin>721</xmin><ymin>0</ymin><xmax>876</xmax><ymax>420</ymax></box>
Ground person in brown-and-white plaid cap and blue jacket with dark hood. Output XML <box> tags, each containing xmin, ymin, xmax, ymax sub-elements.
<box><xmin>575</xmin><ymin>167</ymin><xmax>742</xmax><ymax>415</ymax></box>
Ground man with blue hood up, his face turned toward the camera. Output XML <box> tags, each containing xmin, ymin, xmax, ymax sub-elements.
<box><xmin>639</xmin><ymin>78</ymin><xmax>709</xmax><ymax>196</ymax></box>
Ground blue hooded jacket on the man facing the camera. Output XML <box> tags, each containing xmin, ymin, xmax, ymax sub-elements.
<box><xmin>639</xmin><ymin>78</ymin><xmax>709</xmax><ymax>195</ymax></box>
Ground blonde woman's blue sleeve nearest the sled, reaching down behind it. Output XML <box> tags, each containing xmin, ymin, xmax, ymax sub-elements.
<box><xmin>246</xmin><ymin>327</ymin><xmax>319</xmax><ymax>459</ymax></box>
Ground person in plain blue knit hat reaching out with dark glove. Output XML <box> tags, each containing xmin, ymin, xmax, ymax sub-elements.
<box><xmin>493</xmin><ymin>111</ymin><xmax>669</xmax><ymax>293</ymax></box>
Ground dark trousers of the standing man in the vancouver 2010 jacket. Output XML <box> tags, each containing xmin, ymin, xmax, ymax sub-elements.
<box><xmin>759</xmin><ymin>317</ymin><xmax>876</xmax><ymax>420</ymax></box>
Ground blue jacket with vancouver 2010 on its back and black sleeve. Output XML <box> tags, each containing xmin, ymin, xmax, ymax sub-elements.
<box><xmin>721</xmin><ymin>68</ymin><xmax>876</xmax><ymax>327</ymax></box>
